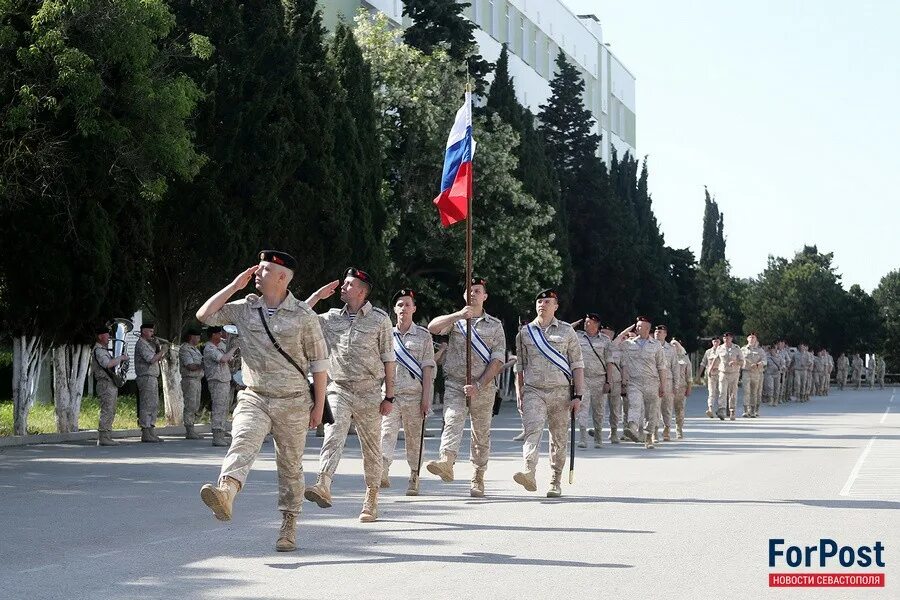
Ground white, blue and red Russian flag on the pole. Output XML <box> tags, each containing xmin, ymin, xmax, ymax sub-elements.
<box><xmin>434</xmin><ymin>92</ymin><xmax>475</xmax><ymax>227</ymax></box>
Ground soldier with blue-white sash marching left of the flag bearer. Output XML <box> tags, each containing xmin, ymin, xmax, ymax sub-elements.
<box><xmin>381</xmin><ymin>288</ymin><xmax>435</xmax><ymax>496</ymax></box>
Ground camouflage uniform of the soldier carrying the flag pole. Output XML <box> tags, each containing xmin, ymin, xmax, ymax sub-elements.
<box><xmin>440</xmin><ymin>313</ymin><xmax>506</xmax><ymax>474</ymax></box>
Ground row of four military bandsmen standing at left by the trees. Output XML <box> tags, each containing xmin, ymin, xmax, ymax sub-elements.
<box><xmin>91</xmin><ymin>322</ymin><xmax>238</xmax><ymax>446</ymax></box>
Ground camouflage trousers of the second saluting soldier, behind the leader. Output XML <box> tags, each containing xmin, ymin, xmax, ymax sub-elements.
<box><xmin>319</xmin><ymin>381</ymin><xmax>384</xmax><ymax>487</ymax></box>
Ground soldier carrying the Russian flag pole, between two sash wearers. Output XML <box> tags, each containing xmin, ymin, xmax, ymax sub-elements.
<box><xmin>426</xmin><ymin>277</ymin><xmax>506</xmax><ymax>498</ymax></box>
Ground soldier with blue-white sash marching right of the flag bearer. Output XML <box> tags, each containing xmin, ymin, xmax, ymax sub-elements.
<box><xmin>513</xmin><ymin>290</ymin><xmax>584</xmax><ymax>498</ymax></box>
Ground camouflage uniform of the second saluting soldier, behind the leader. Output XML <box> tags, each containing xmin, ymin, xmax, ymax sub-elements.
<box><xmin>319</xmin><ymin>302</ymin><xmax>395</xmax><ymax>488</ymax></box>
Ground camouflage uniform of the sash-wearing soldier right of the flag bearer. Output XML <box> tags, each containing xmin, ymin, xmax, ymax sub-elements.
<box><xmin>515</xmin><ymin>318</ymin><xmax>584</xmax><ymax>482</ymax></box>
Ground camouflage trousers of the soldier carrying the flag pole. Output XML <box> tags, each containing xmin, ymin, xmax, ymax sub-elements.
<box><xmin>441</xmin><ymin>381</ymin><xmax>496</xmax><ymax>469</ymax></box>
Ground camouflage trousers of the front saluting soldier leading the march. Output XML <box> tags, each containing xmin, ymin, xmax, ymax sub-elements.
<box><xmin>220</xmin><ymin>389</ymin><xmax>312</xmax><ymax>515</ymax></box>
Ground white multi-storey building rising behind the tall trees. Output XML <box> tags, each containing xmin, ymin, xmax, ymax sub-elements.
<box><xmin>319</xmin><ymin>0</ymin><xmax>637</xmax><ymax>162</ymax></box>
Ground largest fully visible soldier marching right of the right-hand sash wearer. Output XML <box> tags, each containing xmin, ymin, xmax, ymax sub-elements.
<box><xmin>620</xmin><ymin>317</ymin><xmax>669</xmax><ymax>449</ymax></box>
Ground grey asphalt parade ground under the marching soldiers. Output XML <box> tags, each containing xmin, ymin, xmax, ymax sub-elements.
<box><xmin>0</xmin><ymin>389</ymin><xmax>900</xmax><ymax>600</ymax></box>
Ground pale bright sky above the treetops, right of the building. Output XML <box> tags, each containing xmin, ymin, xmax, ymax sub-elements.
<box><xmin>564</xmin><ymin>0</ymin><xmax>900</xmax><ymax>292</ymax></box>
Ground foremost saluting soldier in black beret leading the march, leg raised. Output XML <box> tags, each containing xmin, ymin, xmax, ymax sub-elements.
<box><xmin>197</xmin><ymin>250</ymin><xmax>328</xmax><ymax>552</ymax></box>
